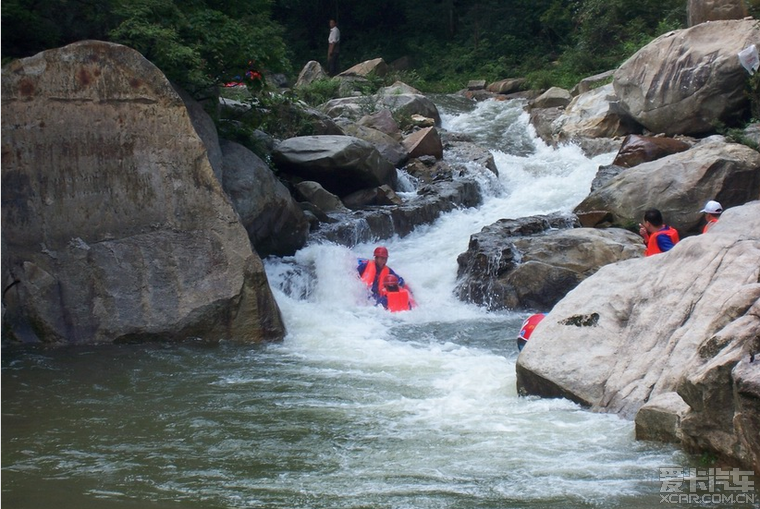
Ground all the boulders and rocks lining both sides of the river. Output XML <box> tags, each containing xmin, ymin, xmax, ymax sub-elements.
<box><xmin>2</xmin><ymin>13</ymin><xmax>760</xmax><ymax>470</ymax></box>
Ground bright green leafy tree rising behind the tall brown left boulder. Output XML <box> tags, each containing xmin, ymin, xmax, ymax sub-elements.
<box><xmin>109</xmin><ymin>0</ymin><xmax>288</xmax><ymax>94</ymax></box>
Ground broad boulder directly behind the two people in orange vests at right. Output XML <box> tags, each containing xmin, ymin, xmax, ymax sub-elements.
<box><xmin>575</xmin><ymin>139</ymin><xmax>760</xmax><ymax>236</ymax></box>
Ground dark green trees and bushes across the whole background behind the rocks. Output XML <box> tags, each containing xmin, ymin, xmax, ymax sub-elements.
<box><xmin>2</xmin><ymin>0</ymin><xmax>760</xmax><ymax>133</ymax></box>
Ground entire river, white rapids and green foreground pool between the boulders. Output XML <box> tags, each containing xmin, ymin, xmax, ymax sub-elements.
<box><xmin>2</xmin><ymin>99</ymin><xmax>756</xmax><ymax>509</ymax></box>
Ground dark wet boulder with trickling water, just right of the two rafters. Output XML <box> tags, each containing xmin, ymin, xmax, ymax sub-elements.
<box><xmin>457</xmin><ymin>214</ymin><xmax>644</xmax><ymax>311</ymax></box>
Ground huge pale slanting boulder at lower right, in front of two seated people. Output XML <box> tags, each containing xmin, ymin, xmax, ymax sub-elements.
<box><xmin>517</xmin><ymin>201</ymin><xmax>760</xmax><ymax>467</ymax></box>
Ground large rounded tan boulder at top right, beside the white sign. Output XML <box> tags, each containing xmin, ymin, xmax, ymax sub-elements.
<box><xmin>613</xmin><ymin>20</ymin><xmax>760</xmax><ymax>135</ymax></box>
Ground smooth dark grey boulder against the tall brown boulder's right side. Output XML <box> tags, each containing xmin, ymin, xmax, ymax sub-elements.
<box><xmin>221</xmin><ymin>140</ymin><xmax>309</xmax><ymax>257</ymax></box>
